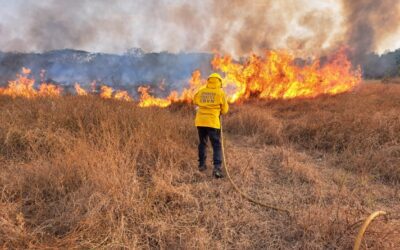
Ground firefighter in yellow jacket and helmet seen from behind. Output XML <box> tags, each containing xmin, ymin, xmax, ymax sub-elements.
<box><xmin>194</xmin><ymin>73</ymin><xmax>229</xmax><ymax>178</ymax></box>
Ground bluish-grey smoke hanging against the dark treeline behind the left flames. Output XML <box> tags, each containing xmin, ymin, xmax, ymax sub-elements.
<box><xmin>0</xmin><ymin>49</ymin><xmax>212</xmax><ymax>96</ymax></box>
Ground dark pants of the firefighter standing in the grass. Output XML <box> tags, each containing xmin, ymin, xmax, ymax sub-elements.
<box><xmin>197</xmin><ymin>127</ymin><xmax>222</xmax><ymax>168</ymax></box>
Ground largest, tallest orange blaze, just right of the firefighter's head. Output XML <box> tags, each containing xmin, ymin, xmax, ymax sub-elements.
<box><xmin>212</xmin><ymin>49</ymin><xmax>361</xmax><ymax>103</ymax></box>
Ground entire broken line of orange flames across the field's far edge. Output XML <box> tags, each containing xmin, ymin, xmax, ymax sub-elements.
<box><xmin>0</xmin><ymin>49</ymin><xmax>361</xmax><ymax>107</ymax></box>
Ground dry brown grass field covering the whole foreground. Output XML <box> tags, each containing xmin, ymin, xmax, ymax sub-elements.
<box><xmin>0</xmin><ymin>83</ymin><xmax>400</xmax><ymax>249</ymax></box>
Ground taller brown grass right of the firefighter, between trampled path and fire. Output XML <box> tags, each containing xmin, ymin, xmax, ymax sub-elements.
<box><xmin>226</xmin><ymin>84</ymin><xmax>400</xmax><ymax>184</ymax></box>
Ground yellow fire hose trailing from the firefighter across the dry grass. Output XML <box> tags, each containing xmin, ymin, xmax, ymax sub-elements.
<box><xmin>220</xmin><ymin>119</ymin><xmax>398</xmax><ymax>247</ymax></box>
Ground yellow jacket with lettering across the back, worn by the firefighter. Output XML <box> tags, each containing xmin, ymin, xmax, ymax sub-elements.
<box><xmin>193</xmin><ymin>78</ymin><xmax>229</xmax><ymax>129</ymax></box>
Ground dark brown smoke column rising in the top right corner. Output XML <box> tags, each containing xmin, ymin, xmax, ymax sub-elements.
<box><xmin>343</xmin><ymin>0</ymin><xmax>400</xmax><ymax>61</ymax></box>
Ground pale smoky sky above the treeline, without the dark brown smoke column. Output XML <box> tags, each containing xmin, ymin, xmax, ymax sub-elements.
<box><xmin>0</xmin><ymin>0</ymin><xmax>400</xmax><ymax>55</ymax></box>
